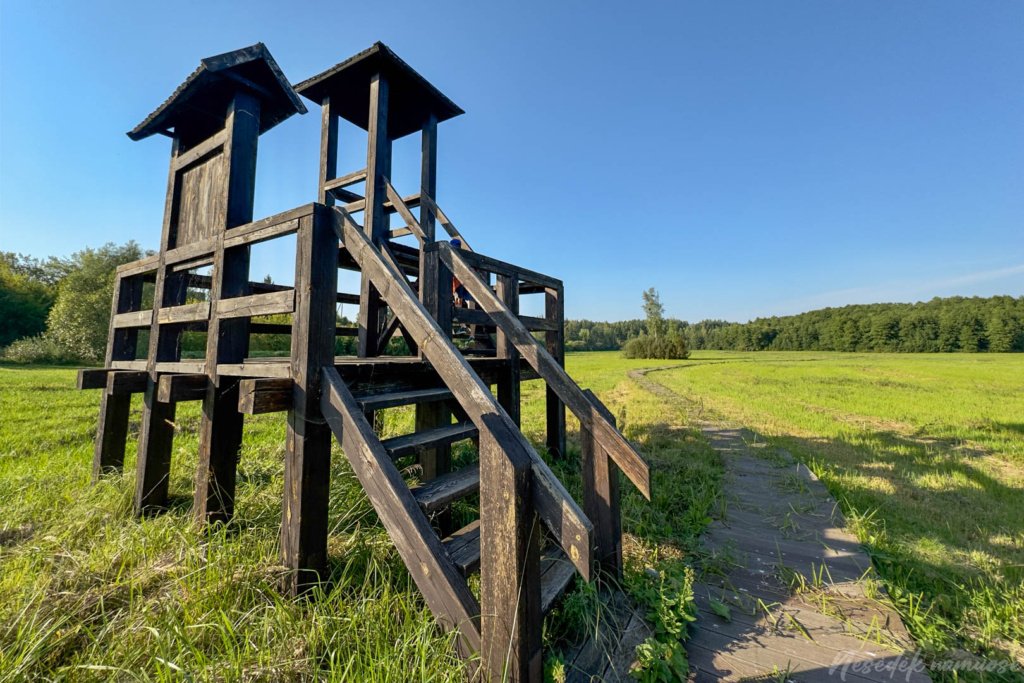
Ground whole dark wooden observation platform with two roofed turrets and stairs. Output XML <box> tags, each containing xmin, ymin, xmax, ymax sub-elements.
<box><xmin>79</xmin><ymin>43</ymin><xmax>649</xmax><ymax>680</ymax></box>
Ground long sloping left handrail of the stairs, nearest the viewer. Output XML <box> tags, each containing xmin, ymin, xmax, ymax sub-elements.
<box><xmin>335</xmin><ymin>216</ymin><xmax>593</xmax><ymax>581</ymax></box>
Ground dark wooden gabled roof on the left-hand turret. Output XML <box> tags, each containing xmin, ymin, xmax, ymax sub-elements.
<box><xmin>128</xmin><ymin>43</ymin><xmax>306</xmax><ymax>140</ymax></box>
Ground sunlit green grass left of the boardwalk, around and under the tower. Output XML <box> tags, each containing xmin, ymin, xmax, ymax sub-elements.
<box><xmin>0</xmin><ymin>354</ymin><xmax>720</xmax><ymax>681</ymax></box>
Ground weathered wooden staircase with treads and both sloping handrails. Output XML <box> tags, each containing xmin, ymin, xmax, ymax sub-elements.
<box><xmin>321</xmin><ymin>202</ymin><xmax>649</xmax><ymax>680</ymax></box>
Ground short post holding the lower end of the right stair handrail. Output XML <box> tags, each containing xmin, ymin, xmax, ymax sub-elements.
<box><xmin>580</xmin><ymin>389</ymin><xmax>623</xmax><ymax>577</ymax></box>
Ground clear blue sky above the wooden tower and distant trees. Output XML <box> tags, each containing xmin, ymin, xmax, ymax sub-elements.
<box><xmin>0</xmin><ymin>0</ymin><xmax>1024</xmax><ymax>321</ymax></box>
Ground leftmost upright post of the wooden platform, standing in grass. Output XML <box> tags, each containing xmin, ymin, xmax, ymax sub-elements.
<box><xmin>92</xmin><ymin>275</ymin><xmax>142</xmax><ymax>482</ymax></box>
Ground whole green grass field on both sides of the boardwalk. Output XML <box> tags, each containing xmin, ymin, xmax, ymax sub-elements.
<box><xmin>0</xmin><ymin>351</ymin><xmax>1024</xmax><ymax>681</ymax></box>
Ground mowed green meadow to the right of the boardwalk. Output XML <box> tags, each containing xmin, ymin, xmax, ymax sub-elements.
<box><xmin>648</xmin><ymin>351</ymin><xmax>1024</xmax><ymax>664</ymax></box>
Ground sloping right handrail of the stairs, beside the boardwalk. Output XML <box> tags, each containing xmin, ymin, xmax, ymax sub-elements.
<box><xmin>439</xmin><ymin>244</ymin><xmax>650</xmax><ymax>500</ymax></box>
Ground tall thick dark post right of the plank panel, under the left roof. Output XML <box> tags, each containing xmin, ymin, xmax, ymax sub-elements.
<box><xmin>193</xmin><ymin>92</ymin><xmax>260</xmax><ymax>522</ymax></box>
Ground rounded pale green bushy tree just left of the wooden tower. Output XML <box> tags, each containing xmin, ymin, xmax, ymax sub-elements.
<box><xmin>46</xmin><ymin>242</ymin><xmax>143</xmax><ymax>361</ymax></box>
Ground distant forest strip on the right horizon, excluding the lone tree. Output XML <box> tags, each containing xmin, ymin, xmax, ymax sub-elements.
<box><xmin>565</xmin><ymin>296</ymin><xmax>1024</xmax><ymax>353</ymax></box>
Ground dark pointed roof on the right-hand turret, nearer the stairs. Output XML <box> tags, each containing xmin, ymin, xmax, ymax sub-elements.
<box><xmin>295</xmin><ymin>41</ymin><xmax>465</xmax><ymax>139</ymax></box>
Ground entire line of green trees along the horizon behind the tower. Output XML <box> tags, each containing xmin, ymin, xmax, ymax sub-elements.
<box><xmin>0</xmin><ymin>242</ymin><xmax>1024</xmax><ymax>362</ymax></box>
